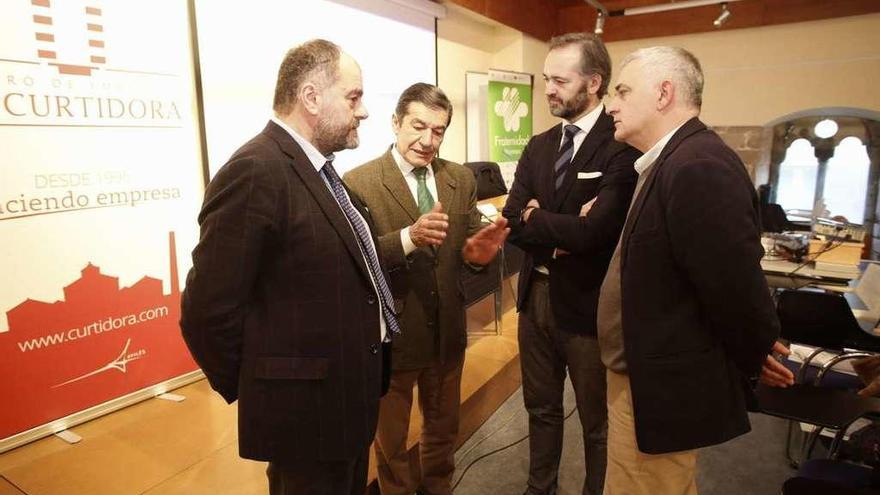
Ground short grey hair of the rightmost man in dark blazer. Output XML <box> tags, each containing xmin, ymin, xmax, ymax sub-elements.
<box><xmin>620</xmin><ymin>46</ymin><xmax>703</xmax><ymax>109</ymax></box>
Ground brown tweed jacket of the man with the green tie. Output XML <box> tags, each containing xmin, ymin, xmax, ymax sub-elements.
<box><xmin>344</xmin><ymin>149</ymin><xmax>480</xmax><ymax>370</ymax></box>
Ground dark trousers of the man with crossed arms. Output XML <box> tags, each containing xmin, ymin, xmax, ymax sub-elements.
<box><xmin>519</xmin><ymin>274</ymin><xmax>608</xmax><ymax>495</ymax></box>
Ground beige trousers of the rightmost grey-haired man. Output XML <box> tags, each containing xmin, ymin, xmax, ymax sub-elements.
<box><xmin>604</xmin><ymin>371</ymin><xmax>697</xmax><ymax>495</ymax></box>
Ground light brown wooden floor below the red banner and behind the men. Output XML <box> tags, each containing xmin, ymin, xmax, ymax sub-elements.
<box><xmin>0</xmin><ymin>277</ymin><xmax>520</xmax><ymax>495</ymax></box>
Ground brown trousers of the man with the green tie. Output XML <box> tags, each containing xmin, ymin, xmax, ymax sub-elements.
<box><xmin>373</xmin><ymin>354</ymin><xmax>464</xmax><ymax>495</ymax></box>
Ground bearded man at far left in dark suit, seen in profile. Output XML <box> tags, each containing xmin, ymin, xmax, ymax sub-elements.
<box><xmin>181</xmin><ymin>40</ymin><xmax>399</xmax><ymax>495</ymax></box>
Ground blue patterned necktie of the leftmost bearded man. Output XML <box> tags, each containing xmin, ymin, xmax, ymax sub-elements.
<box><xmin>321</xmin><ymin>161</ymin><xmax>400</xmax><ymax>333</ymax></box>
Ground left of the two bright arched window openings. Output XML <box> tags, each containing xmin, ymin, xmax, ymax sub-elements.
<box><xmin>776</xmin><ymin>139</ymin><xmax>819</xmax><ymax>211</ymax></box>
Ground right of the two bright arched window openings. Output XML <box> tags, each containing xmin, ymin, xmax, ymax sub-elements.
<box><xmin>823</xmin><ymin>136</ymin><xmax>871</xmax><ymax>224</ymax></box>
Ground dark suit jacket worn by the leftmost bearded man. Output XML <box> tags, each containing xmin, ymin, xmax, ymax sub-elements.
<box><xmin>181</xmin><ymin>122</ymin><xmax>388</xmax><ymax>463</ymax></box>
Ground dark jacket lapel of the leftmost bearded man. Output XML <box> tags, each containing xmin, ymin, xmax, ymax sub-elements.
<box><xmin>263</xmin><ymin>122</ymin><xmax>372</xmax><ymax>283</ymax></box>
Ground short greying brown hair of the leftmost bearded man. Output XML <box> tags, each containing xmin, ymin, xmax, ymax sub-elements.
<box><xmin>272</xmin><ymin>39</ymin><xmax>342</xmax><ymax>115</ymax></box>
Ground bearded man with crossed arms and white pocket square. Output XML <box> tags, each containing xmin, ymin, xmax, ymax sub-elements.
<box><xmin>504</xmin><ymin>33</ymin><xmax>637</xmax><ymax>495</ymax></box>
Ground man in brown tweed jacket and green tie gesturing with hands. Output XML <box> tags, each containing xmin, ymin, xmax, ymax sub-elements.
<box><xmin>345</xmin><ymin>83</ymin><xmax>508</xmax><ymax>495</ymax></box>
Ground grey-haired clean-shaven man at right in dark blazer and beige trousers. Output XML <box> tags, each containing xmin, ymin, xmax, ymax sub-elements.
<box><xmin>600</xmin><ymin>47</ymin><xmax>792</xmax><ymax>495</ymax></box>
